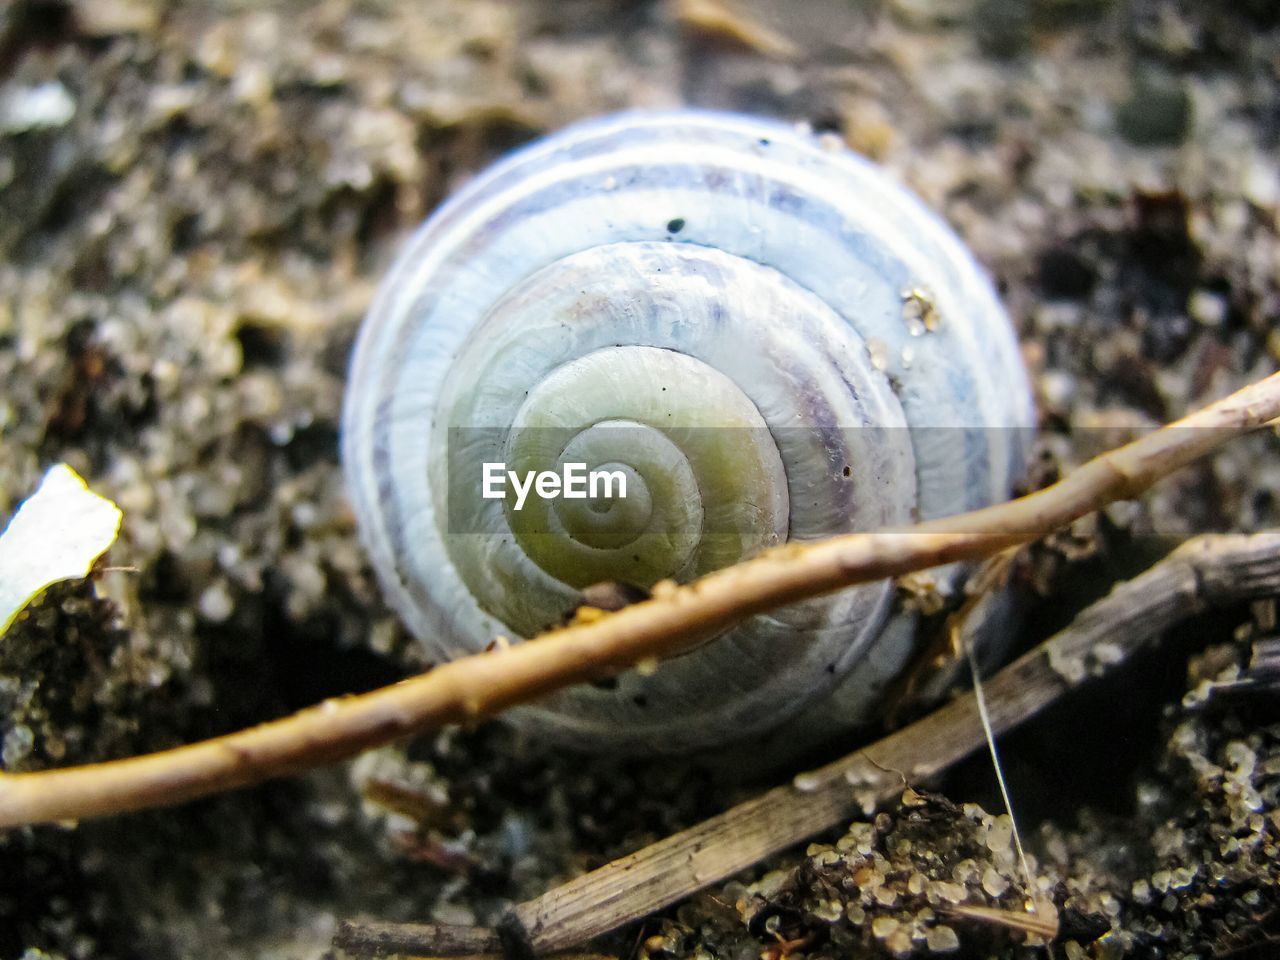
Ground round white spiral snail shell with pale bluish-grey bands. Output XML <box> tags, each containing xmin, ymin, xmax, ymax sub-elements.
<box><xmin>343</xmin><ymin>111</ymin><xmax>1032</xmax><ymax>751</ymax></box>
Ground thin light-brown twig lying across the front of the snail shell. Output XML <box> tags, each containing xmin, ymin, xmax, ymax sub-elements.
<box><xmin>0</xmin><ymin>374</ymin><xmax>1280</xmax><ymax>828</ymax></box>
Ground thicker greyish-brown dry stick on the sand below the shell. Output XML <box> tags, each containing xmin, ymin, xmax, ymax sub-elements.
<box><xmin>334</xmin><ymin>531</ymin><xmax>1280</xmax><ymax>956</ymax></box>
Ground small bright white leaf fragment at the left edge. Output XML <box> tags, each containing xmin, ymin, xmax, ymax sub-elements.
<box><xmin>0</xmin><ymin>463</ymin><xmax>122</xmax><ymax>634</ymax></box>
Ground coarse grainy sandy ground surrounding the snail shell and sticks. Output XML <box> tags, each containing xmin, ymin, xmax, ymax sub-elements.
<box><xmin>0</xmin><ymin>0</ymin><xmax>1280</xmax><ymax>960</ymax></box>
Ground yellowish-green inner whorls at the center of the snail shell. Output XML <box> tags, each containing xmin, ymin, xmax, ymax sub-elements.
<box><xmin>506</xmin><ymin>346</ymin><xmax>787</xmax><ymax>588</ymax></box>
